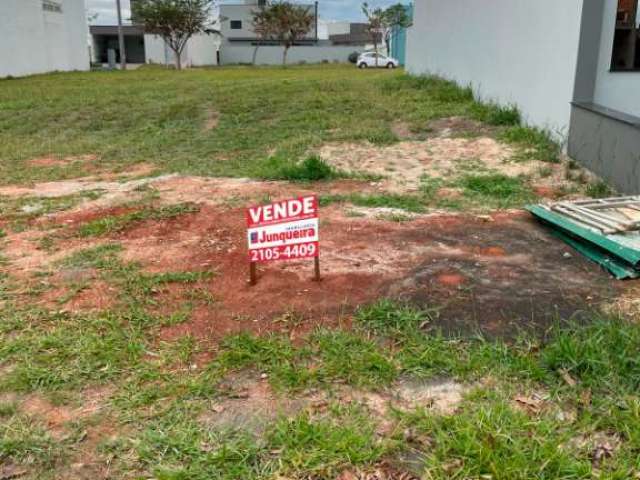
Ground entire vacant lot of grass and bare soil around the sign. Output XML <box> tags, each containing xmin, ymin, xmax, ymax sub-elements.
<box><xmin>0</xmin><ymin>65</ymin><xmax>640</xmax><ymax>480</ymax></box>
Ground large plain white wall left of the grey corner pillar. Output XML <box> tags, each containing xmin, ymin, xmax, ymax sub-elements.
<box><xmin>406</xmin><ymin>0</ymin><xmax>583</xmax><ymax>137</ymax></box>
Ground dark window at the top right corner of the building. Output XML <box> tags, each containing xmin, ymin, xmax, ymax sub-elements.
<box><xmin>611</xmin><ymin>0</ymin><xmax>640</xmax><ymax>71</ymax></box>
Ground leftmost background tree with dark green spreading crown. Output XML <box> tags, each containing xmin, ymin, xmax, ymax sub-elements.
<box><xmin>131</xmin><ymin>0</ymin><xmax>220</xmax><ymax>70</ymax></box>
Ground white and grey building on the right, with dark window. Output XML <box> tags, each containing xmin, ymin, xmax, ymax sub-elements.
<box><xmin>406</xmin><ymin>0</ymin><xmax>640</xmax><ymax>193</ymax></box>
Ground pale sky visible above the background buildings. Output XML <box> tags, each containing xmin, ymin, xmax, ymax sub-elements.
<box><xmin>86</xmin><ymin>0</ymin><xmax>398</xmax><ymax>25</ymax></box>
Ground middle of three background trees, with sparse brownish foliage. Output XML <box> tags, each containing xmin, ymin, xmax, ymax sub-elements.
<box><xmin>253</xmin><ymin>0</ymin><xmax>315</xmax><ymax>65</ymax></box>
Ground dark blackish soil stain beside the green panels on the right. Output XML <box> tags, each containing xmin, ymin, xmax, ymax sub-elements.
<box><xmin>386</xmin><ymin>214</ymin><xmax>620</xmax><ymax>338</ymax></box>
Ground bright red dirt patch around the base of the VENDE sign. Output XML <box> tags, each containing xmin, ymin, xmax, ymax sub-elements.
<box><xmin>115</xmin><ymin>206</ymin><xmax>383</xmax><ymax>340</ymax></box>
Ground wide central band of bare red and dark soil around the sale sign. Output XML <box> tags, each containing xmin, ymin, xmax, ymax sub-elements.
<box><xmin>3</xmin><ymin>158</ymin><xmax>624</xmax><ymax>343</ymax></box>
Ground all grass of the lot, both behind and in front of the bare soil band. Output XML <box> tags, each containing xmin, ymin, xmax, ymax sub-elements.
<box><xmin>0</xmin><ymin>66</ymin><xmax>640</xmax><ymax>480</ymax></box>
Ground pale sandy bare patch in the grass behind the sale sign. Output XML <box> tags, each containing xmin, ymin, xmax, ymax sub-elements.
<box><xmin>320</xmin><ymin>117</ymin><xmax>574</xmax><ymax>198</ymax></box>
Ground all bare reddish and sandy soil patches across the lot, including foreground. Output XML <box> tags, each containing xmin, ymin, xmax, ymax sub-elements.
<box><xmin>0</xmin><ymin>118</ymin><xmax>638</xmax><ymax>480</ymax></box>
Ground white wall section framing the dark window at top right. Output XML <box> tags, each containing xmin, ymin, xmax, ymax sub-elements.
<box><xmin>593</xmin><ymin>0</ymin><xmax>640</xmax><ymax>117</ymax></box>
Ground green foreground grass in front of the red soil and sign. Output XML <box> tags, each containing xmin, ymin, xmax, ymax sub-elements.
<box><xmin>0</xmin><ymin>286</ymin><xmax>640</xmax><ymax>480</ymax></box>
